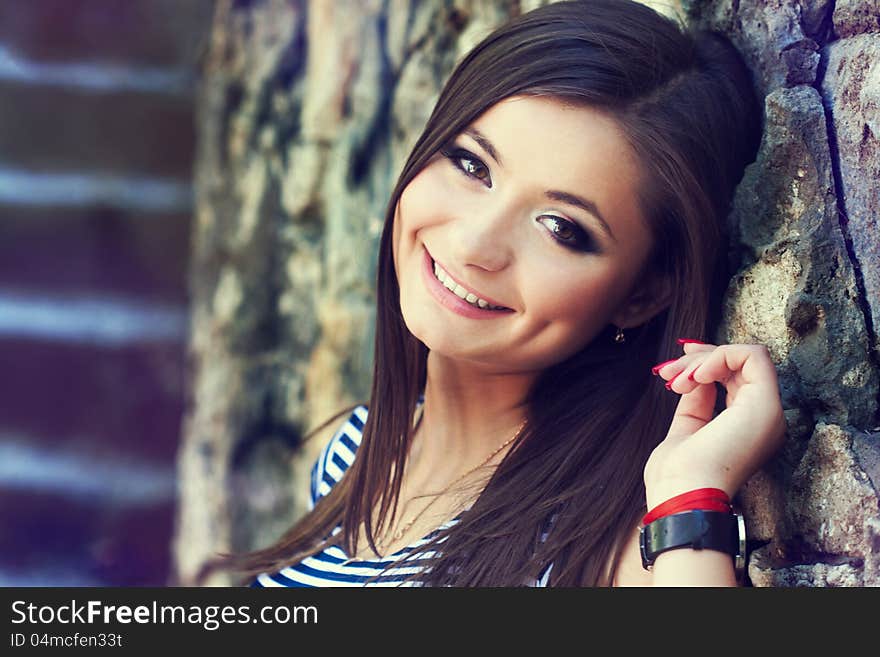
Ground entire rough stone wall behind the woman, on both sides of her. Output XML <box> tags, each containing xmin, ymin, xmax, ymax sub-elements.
<box><xmin>176</xmin><ymin>0</ymin><xmax>880</xmax><ymax>586</ymax></box>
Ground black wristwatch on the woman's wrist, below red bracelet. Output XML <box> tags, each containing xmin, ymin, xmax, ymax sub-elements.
<box><xmin>639</xmin><ymin>510</ymin><xmax>746</xmax><ymax>579</ymax></box>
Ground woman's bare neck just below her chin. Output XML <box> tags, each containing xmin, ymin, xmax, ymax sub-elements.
<box><xmin>410</xmin><ymin>352</ymin><xmax>534</xmax><ymax>473</ymax></box>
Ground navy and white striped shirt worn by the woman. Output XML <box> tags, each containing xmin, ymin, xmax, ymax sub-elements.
<box><xmin>250</xmin><ymin>396</ymin><xmax>552</xmax><ymax>588</ymax></box>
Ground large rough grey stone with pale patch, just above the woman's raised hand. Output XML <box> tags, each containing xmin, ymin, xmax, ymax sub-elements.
<box><xmin>719</xmin><ymin>85</ymin><xmax>878</xmax><ymax>426</ymax></box>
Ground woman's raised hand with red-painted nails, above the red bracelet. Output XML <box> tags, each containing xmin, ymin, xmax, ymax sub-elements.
<box><xmin>645</xmin><ymin>342</ymin><xmax>786</xmax><ymax>509</ymax></box>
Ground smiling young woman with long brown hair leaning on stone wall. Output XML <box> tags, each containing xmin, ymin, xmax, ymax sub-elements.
<box><xmin>210</xmin><ymin>0</ymin><xmax>785</xmax><ymax>586</ymax></box>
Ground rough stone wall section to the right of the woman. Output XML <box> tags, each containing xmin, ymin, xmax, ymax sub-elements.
<box><xmin>689</xmin><ymin>0</ymin><xmax>880</xmax><ymax>586</ymax></box>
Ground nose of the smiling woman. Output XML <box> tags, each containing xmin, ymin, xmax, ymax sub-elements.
<box><xmin>453</xmin><ymin>199</ymin><xmax>515</xmax><ymax>272</ymax></box>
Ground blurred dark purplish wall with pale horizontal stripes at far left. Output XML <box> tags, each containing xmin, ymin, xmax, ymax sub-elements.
<box><xmin>0</xmin><ymin>0</ymin><xmax>213</xmax><ymax>586</ymax></box>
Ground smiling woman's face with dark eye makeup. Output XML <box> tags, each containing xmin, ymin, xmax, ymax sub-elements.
<box><xmin>393</xmin><ymin>96</ymin><xmax>653</xmax><ymax>372</ymax></box>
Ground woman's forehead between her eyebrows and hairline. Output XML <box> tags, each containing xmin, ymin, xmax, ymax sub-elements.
<box><xmin>465</xmin><ymin>96</ymin><xmax>641</xmax><ymax>229</ymax></box>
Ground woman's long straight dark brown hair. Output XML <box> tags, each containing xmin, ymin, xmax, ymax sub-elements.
<box><xmin>205</xmin><ymin>0</ymin><xmax>761</xmax><ymax>586</ymax></box>
